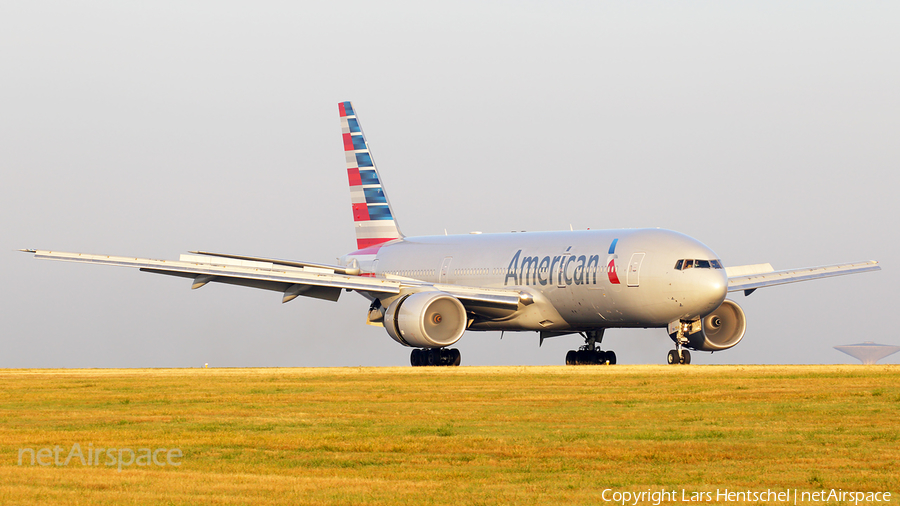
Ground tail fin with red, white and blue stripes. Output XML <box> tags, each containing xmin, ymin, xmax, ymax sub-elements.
<box><xmin>338</xmin><ymin>102</ymin><xmax>403</xmax><ymax>249</ymax></box>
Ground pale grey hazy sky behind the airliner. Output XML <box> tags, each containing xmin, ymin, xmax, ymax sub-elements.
<box><xmin>0</xmin><ymin>2</ymin><xmax>900</xmax><ymax>367</ymax></box>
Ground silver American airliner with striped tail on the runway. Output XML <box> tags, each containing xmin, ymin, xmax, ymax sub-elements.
<box><xmin>22</xmin><ymin>102</ymin><xmax>881</xmax><ymax>366</ymax></box>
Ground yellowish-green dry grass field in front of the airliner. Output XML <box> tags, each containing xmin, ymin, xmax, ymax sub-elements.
<box><xmin>0</xmin><ymin>366</ymin><xmax>900</xmax><ymax>505</ymax></box>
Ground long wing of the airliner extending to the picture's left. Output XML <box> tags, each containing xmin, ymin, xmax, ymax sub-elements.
<box><xmin>22</xmin><ymin>249</ymin><xmax>531</xmax><ymax>310</ymax></box>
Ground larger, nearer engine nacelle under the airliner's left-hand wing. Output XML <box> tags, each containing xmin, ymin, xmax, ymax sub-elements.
<box><xmin>384</xmin><ymin>292</ymin><xmax>466</xmax><ymax>348</ymax></box>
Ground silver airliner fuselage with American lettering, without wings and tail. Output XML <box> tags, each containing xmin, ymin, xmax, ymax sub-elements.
<box><xmin>341</xmin><ymin>229</ymin><xmax>728</xmax><ymax>331</ymax></box>
